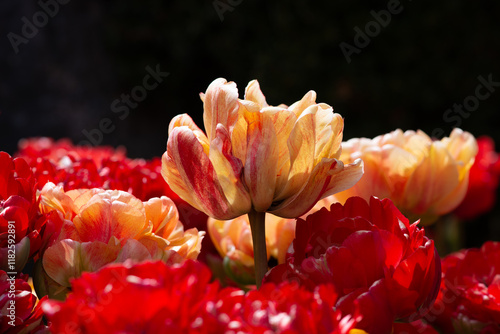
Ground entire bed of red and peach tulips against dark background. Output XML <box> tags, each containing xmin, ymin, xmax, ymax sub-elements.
<box><xmin>0</xmin><ymin>79</ymin><xmax>500</xmax><ymax>334</ymax></box>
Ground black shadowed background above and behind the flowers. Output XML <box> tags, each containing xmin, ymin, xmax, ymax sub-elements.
<box><xmin>0</xmin><ymin>0</ymin><xmax>500</xmax><ymax>245</ymax></box>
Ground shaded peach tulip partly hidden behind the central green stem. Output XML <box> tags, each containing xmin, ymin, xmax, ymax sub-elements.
<box><xmin>207</xmin><ymin>213</ymin><xmax>295</xmax><ymax>284</ymax></box>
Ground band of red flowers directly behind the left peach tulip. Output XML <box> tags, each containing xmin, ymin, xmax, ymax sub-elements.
<box><xmin>16</xmin><ymin>138</ymin><xmax>207</xmax><ymax>227</ymax></box>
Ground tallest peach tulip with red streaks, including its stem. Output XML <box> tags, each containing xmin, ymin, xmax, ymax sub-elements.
<box><xmin>162</xmin><ymin>79</ymin><xmax>362</xmax><ymax>285</ymax></box>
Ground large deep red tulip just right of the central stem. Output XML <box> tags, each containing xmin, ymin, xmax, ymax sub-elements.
<box><xmin>264</xmin><ymin>197</ymin><xmax>441</xmax><ymax>334</ymax></box>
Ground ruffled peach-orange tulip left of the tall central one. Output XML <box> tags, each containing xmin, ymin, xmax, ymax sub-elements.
<box><xmin>36</xmin><ymin>183</ymin><xmax>205</xmax><ymax>294</ymax></box>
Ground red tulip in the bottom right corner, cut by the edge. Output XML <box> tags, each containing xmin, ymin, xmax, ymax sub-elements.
<box><xmin>426</xmin><ymin>241</ymin><xmax>500</xmax><ymax>333</ymax></box>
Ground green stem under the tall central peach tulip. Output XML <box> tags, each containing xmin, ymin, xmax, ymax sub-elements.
<box><xmin>248</xmin><ymin>209</ymin><xmax>267</xmax><ymax>289</ymax></box>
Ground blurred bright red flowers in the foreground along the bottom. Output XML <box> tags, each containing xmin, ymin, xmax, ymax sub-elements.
<box><xmin>42</xmin><ymin>261</ymin><xmax>357</xmax><ymax>334</ymax></box>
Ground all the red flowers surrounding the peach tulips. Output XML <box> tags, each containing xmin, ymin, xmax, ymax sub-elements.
<box><xmin>0</xmin><ymin>132</ymin><xmax>500</xmax><ymax>334</ymax></box>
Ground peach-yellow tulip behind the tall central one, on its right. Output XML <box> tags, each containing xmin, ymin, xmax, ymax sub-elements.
<box><xmin>327</xmin><ymin>129</ymin><xmax>477</xmax><ymax>224</ymax></box>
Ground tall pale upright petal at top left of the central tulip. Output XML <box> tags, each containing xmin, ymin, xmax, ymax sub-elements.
<box><xmin>203</xmin><ymin>78</ymin><xmax>239</xmax><ymax>141</ymax></box>
